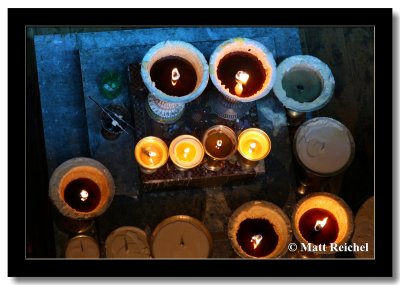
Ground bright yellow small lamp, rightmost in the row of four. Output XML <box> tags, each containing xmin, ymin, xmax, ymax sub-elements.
<box><xmin>238</xmin><ymin>128</ymin><xmax>271</xmax><ymax>169</ymax></box>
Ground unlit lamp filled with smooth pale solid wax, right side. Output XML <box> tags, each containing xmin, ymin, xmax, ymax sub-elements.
<box><xmin>295</xmin><ymin>117</ymin><xmax>354</xmax><ymax>174</ymax></box>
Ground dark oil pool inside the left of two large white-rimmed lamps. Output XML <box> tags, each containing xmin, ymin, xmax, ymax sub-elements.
<box><xmin>150</xmin><ymin>56</ymin><xmax>197</xmax><ymax>96</ymax></box>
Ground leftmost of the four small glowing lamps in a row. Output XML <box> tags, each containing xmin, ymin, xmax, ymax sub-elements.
<box><xmin>134</xmin><ymin>136</ymin><xmax>168</xmax><ymax>174</ymax></box>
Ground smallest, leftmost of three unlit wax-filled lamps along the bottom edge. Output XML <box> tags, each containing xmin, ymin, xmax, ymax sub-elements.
<box><xmin>65</xmin><ymin>235</ymin><xmax>100</xmax><ymax>259</ymax></box>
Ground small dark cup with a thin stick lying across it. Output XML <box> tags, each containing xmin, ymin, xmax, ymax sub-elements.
<box><xmin>100</xmin><ymin>104</ymin><xmax>131</xmax><ymax>140</ymax></box>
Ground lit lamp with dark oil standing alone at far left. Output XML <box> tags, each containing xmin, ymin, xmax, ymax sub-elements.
<box><xmin>49</xmin><ymin>157</ymin><xmax>115</xmax><ymax>224</ymax></box>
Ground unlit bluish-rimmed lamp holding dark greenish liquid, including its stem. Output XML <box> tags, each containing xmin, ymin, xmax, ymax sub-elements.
<box><xmin>273</xmin><ymin>55</ymin><xmax>335</xmax><ymax>126</ymax></box>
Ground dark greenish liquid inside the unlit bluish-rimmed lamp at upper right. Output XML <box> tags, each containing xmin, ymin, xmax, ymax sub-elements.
<box><xmin>282</xmin><ymin>68</ymin><xmax>322</xmax><ymax>103</ymax></box>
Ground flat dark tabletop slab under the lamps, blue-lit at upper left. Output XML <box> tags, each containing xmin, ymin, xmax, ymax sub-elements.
<box><xmin>35</xmin><ymin>27</ymin><xmax>301</xmax><ymax>258</ymax></box>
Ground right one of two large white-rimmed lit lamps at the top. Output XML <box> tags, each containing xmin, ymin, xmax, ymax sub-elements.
<box><xmin>210</xmin><ymin>38</ymin><xmax>276</xmax><ymax>119</ymax></box>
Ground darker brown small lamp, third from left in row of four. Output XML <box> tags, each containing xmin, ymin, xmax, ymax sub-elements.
<box><xmin>202</xmin><ymin>125</ymin><xmax>237</xmax><ymax>171</ymax></box>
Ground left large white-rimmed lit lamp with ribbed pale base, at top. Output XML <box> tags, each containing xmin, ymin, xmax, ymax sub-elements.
<box><xmin>141</xmin><ymin>41</ymin><xmax>209</xmax><ymax>124</ymax></box>
